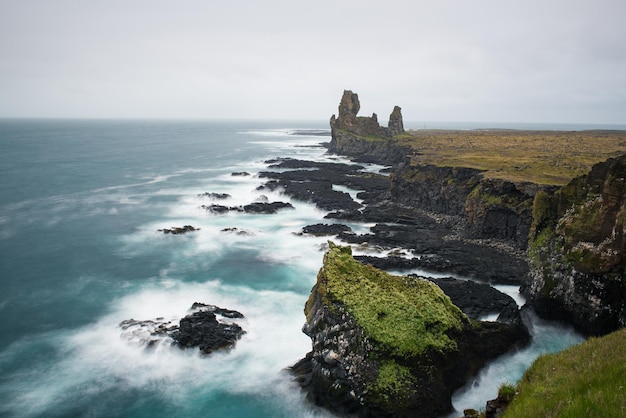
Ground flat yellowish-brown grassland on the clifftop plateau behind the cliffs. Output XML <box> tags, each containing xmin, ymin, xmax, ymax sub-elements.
<box><xmin>394</xmin><ymin>130</ymin><xmax>626</xmax><ymax>185</ymax></box>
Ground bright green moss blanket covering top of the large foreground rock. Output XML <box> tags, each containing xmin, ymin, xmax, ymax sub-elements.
<box><xmin>317</xmin><ymin>243</ymin><xmax>469</xmax><ymax>356</ymax></box>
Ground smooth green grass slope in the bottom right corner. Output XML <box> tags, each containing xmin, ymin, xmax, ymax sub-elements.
<box><xmin>504</xmin><ymin>329</ymin><xmax>626</xmax><ymax>418</ymax></box>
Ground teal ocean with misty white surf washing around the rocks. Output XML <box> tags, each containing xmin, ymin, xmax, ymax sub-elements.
<box><xmin>0</xmin><ymin>120</ymin><xmax>582</xmax><ymax>418</ymax></box>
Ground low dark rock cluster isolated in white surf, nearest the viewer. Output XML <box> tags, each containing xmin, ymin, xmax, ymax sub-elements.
<box><xmin>119</xmin><ymin>302</ymin><xmax>245</xmax><ymax>354</ymax></box>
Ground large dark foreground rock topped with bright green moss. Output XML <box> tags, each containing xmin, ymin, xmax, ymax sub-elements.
<box><xmin>294</xmin><ymin>243</ymin><xmax>528</xmax><ymax>417</ymax></box>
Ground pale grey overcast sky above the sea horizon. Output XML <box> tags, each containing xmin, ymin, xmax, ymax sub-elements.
<box><xmin>0</xmin><ymin>0</ymin><xmax>626</xmax><ymax>124</ymax></box>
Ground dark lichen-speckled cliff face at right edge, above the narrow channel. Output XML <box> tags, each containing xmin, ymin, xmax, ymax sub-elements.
<box><xmin>524</xmin><ymin>156</ymin><xmax>626</xmax><ymax>335</ymax></box>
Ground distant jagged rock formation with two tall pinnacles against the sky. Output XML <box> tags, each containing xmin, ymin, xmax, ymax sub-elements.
<box><xmin>329</xmin><ymin>90</ymin><xmax>409</xmax><ymax>164</ymax></box>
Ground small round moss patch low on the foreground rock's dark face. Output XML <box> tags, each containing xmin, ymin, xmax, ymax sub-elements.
<box><xmin>367</xmin><ymin>360</ymin><xmax>415</xmax><ymax>408</ymax></box>
